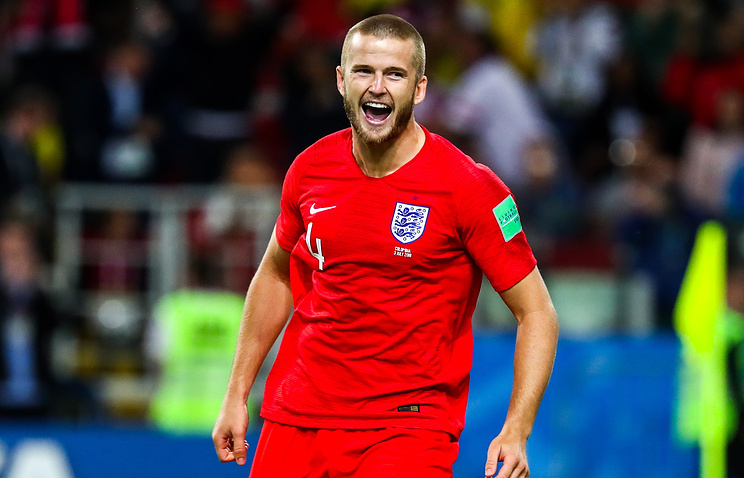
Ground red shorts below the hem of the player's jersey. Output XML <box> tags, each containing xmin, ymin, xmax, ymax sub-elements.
<box><xmin>250</xmin><ymin>420</ymin><xmax>460</xmax><ymax>478</ymax></box>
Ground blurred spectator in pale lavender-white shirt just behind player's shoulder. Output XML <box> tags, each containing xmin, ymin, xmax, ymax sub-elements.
<box><xmin>442</xmin><ymin>6</ymin><xmax>555</xmax><ymax>194</ymax></box>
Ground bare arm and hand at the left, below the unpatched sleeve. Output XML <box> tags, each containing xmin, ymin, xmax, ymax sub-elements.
<box><xmin>212</xmin><ymin>231</ymin><xmax>292</xmax><ymax>465</ymax></box>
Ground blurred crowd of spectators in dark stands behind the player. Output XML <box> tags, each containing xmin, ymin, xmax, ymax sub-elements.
<box><xmin>0</xmin><ymin>0</ymin><xmax>744</xmax><ymax>422</ymax></box>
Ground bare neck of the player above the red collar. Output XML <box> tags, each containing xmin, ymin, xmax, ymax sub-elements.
<box><xmin>352</xmin><ymin>120</ymin><xmax>426</xmax><ymax>178</ymax></box>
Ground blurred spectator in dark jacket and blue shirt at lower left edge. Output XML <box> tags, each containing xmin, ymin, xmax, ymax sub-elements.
<box><xmin>0</xmin><ymin>215</ymin><xmax>61</xmax><ymax>419</ymax></box>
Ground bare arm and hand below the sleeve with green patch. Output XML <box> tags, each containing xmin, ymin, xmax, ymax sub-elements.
<box><xmin>486</xmin><ymin>267</ymin><xmax>558</xmax><ymax>478</ymax></box>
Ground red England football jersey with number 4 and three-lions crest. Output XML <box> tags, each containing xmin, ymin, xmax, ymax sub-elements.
<box><xmin>262</xmin><ymin>129</ymin><xmax>535</xmax><ymax>437</ymax></box>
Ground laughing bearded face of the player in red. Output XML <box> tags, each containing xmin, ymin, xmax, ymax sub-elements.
<box><xmin>336</xmin><ymin>34</ymin><xmax>427</xmax><ymax>144</ymax></box>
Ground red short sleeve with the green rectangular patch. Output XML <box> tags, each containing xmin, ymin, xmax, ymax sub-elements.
<box><xmin>453</xmin><ymin>165</ymin><xmax>537</xmax><ymax>292</ymax></box>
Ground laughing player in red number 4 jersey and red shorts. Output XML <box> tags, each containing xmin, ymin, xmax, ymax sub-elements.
<box><xmin>212</xmin><ymin>15</ymin><xmax>558</xmax><ymax>478</ymax></box>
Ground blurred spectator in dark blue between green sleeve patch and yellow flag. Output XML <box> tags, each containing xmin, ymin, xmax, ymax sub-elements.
<box><xmin>590</xmin><ymin>119</ymin><xmax>695</xmax><ymax>329</ymax></box>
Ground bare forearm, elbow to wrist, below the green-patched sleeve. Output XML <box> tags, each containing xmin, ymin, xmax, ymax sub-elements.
<box><xmin>502</xmin><ymin>309</ymin><xmax>558</xmax><ymax>440</ymax></box>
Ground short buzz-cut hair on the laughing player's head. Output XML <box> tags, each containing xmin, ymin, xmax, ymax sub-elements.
<box><xmin>341</xmin><ymin>14</ymin><xmax>426</xmax><ymax>80</ymax></box>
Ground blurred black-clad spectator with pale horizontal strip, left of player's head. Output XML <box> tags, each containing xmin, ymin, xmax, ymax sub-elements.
<box><xmin>173</xmin><ymin>0</ymin><xmax>276</xmax><ymax>183</ymax></box>
